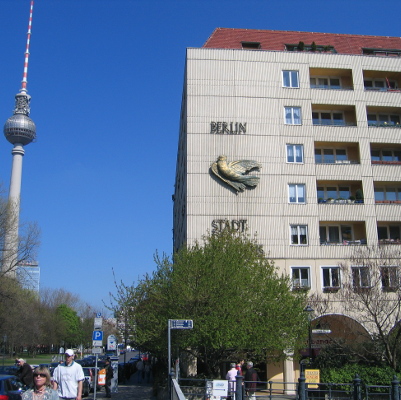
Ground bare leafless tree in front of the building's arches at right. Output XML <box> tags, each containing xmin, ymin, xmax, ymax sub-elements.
<box><xmin>310</xmin><ymin>245</ymin><xmax>401</xmax><ymax>370</ymax></box>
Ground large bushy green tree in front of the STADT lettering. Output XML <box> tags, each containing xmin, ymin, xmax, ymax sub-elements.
<box><xmin>114</xmin><ymin>231</ymin><xmax>307</xmax><ymax>375</ymax></box>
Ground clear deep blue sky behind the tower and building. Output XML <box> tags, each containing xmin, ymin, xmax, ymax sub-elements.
<box><xmin>0</xmin><ymin>0</ymin><xmax>401</xmax><ymax>314</ymax></box>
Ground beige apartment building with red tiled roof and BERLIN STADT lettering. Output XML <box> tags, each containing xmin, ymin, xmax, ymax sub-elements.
<box><xmin>174</xmin><ymin>28</ymin><xmax>401</xmax><ymax>382</ymax></box>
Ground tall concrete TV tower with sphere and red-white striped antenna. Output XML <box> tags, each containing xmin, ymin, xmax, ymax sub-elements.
<box><xmin>2</xmin><ymin>0</ymin><xmax>36</xmax><ymax>276</ymax></box>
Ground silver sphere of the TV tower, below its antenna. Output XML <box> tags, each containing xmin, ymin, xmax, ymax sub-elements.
<box><xmin>4</xmin><ymin>92</ymin><xmax>36</xmax><ymax>146</ymax></box>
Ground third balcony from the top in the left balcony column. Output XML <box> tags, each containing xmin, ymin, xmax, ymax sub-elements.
<box><xmin>315</xmin><ymin>142</ymin><xmax>360</xmax><ymax>165</ymax></box>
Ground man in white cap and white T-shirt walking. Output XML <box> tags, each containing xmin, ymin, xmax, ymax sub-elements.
<box><xmin>53</xmin><ymin>349</ymin><xmax>85</xmax><ymax>400</ymax></box>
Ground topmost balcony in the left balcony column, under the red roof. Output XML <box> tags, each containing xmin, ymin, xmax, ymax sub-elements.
<box><xmin>309</xmin><ymin>68</ymin><xmax>354</xmax><ymax>90</ymax></box>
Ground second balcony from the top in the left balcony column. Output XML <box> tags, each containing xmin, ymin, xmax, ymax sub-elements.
<box><xmin>312</xmin><ymin>104</ymin><xmax>357</xmax><ymax>127</ymax></box>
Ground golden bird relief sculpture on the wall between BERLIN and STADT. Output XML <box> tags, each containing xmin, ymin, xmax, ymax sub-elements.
<box><xmin>210</xmin><ymin>156</ymin><xmax>262</xmax><ymax>192</ymax></box>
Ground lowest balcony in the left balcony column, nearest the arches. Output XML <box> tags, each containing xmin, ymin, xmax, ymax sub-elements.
<box><xmin>319</xmin><ymin>221</ymin><xmax>367</xmax><ymax>246</ymax></box>
